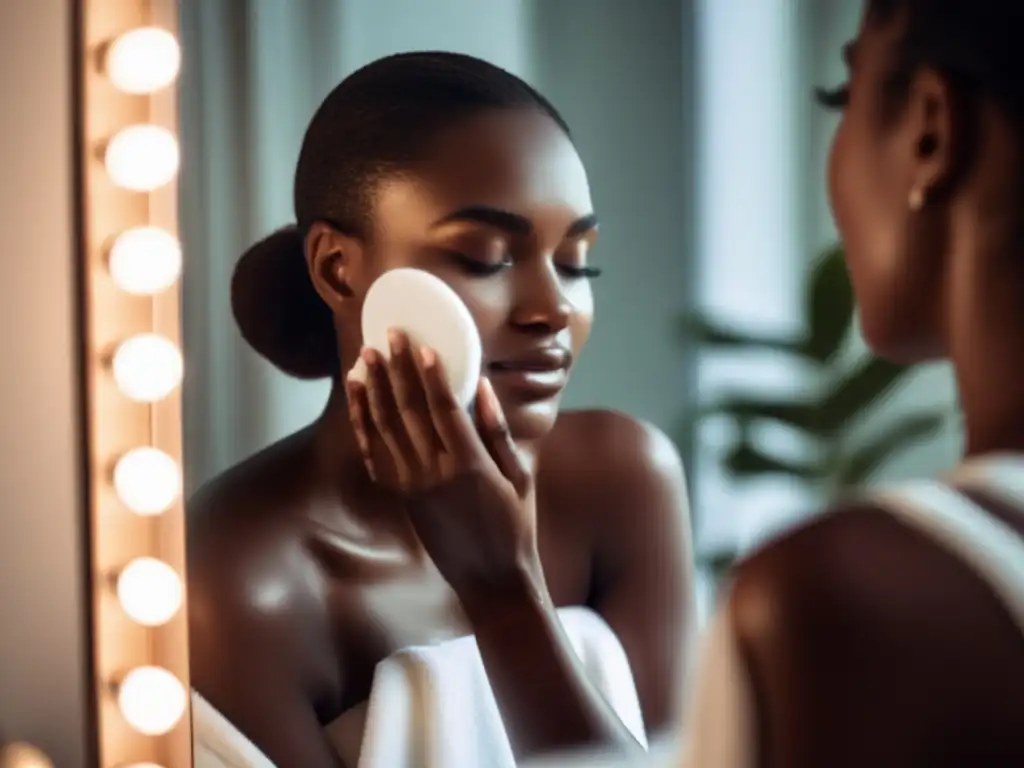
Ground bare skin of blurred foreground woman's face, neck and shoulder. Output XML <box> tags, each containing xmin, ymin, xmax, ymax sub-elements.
<box><xmin>728</xmin><ymin>6</ymin><xmax>1024</xmax><ymax>768</ymax></box>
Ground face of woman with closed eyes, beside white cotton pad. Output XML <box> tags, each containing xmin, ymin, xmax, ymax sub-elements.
<box><xmin>356</xmin><ymin>110</ymin><xmax>597</xmax><ymax>439</ymax></box>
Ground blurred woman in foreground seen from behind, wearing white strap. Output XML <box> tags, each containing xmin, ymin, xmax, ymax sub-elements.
<box><xmin>688</xmin><ymin>0</ymin><xmax>1024</xmax><ymax>768</ymax></box>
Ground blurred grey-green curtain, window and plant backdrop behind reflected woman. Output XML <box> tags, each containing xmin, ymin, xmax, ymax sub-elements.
<box><xmin>181</xmin><ymin>0</ymin><xmax>959</xmax><ymax>622</ymax></box>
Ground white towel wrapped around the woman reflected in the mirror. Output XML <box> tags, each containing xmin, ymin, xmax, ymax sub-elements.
<box><xmin>193</xmin><ymin>608</ymin><xmax>647</xmax><ymax>768</ymax></box>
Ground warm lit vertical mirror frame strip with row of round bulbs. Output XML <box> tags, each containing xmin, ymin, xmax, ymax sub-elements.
<box><xmin>78</xmin><ymin>0</ymin><xmax>191</xmax><ymax>768</ymax></box>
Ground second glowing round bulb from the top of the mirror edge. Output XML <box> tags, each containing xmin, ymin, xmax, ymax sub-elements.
<box><xmin>103</xmin><ymin>124</ymin><xmax>178</xmax><ymax>191</ymax></box>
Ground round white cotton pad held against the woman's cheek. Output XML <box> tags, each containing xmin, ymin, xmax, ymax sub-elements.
<box><xmin>349</xmin><ymin>267</ymin><xmax>483</xmax><ymax>407</ymax></box>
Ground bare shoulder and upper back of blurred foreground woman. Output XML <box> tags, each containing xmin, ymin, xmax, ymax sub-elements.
<box><xmin>727</xmin><ymin>504</ymin><xmax>1024</xmax><ymax>766</ymax></box>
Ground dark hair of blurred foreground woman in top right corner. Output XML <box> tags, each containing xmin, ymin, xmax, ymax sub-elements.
<box><xmin>867</xmin><ymin>0</ymin><xmax>1024</xmax><ymax>123</ymax></box>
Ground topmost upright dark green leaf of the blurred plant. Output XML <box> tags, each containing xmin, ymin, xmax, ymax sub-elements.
<box><xmin>804</xmin><ymin>246</ymin><xmax>854</xmax><ymax>362</ymax></box>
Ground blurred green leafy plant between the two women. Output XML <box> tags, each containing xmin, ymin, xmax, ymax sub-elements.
<box><xmin>686</xmin><ymin>246</ymin><xmax>946</xmax><ymax>569</ymax></box>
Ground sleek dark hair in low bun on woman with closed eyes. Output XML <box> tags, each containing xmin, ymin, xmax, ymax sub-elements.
<box><xmin>231</xmin><ymin>52</ymin><xmax>569</xmax><ymax>379</ymax></box>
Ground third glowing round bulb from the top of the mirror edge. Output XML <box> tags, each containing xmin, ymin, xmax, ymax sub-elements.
<box><xmin>108</xmin><ymin>226</ymin><xmax>181</xmax><ymax>296</ymax></box>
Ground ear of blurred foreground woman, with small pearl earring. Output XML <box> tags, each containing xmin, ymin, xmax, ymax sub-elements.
<box><xmin>906</xmin><ymin>70</ymin><xmax>967</xmax><ymax>204</ymax></box>
